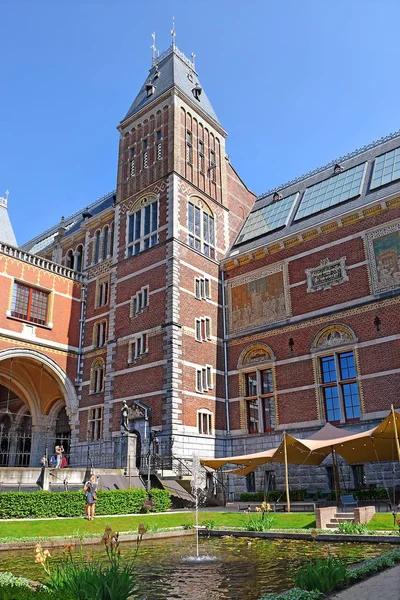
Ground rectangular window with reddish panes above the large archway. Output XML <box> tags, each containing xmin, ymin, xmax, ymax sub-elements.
<box><xmin>11</xmin><ymin>282</ymin><xmax>49</xmax><ymax>325</ymax></box>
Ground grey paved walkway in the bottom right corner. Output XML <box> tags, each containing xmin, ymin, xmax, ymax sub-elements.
<box><xmin>329</xmin><ymin>565</ymin><xmax>400</xmax><ymax>600</ymax></box>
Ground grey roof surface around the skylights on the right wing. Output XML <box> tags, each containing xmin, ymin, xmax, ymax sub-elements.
<box><xmin>229</xmin><ymin>131</ymin><xmax>400</xmax><ymax>257</ymax></box>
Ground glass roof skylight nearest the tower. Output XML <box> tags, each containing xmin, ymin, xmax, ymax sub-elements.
<box><xmin>236</xmin><ymin>192</ymin><xmax>299</xmax><ymax>244</ymax></box>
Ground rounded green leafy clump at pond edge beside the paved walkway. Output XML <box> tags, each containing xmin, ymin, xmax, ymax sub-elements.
<box><xmin>293</xmin><ymin>556</ymin><xmax>349</xmax><ymax>593</ymax></box>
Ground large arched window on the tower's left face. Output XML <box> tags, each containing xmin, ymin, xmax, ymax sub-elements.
<box><xmin>127</xmin><ymin>198</ymin><xmax>158</xmax><ymax>257</ymax></box>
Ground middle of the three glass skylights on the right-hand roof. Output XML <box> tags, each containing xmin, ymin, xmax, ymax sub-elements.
<box><xmin>294</xmin><ymin>163</ymin><xmax>367</xmax><ymax>221</ymax></box>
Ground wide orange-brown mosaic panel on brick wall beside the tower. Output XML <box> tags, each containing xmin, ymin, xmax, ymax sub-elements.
<box><xmin>227</xmin><ymin>264</ymin><xmax>290</xmax><ymax>333</ymax></box>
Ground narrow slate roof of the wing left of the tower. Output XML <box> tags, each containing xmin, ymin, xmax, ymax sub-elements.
<box><xmin>20</xmin><ymin>190</ymin><xmax>116</xmax><ymax>254</ymax></box>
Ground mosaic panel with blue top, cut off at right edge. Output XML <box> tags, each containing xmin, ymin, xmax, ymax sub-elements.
<box><xmin>366</xmin><ymin>223</ymin><xmax>400</xmax><ymax>294</ymax></box>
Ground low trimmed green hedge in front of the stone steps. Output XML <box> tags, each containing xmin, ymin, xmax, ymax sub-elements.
<box><xmin>0</xmin><ymin>489</ymin><xmax>171</xmax><ymax>519</ymax></box>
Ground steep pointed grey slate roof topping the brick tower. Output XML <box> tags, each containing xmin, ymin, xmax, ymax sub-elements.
<box><xmin>122</xmin><ymin>44</ymin><xmax>221</xmax><ymax>127</ymax></box>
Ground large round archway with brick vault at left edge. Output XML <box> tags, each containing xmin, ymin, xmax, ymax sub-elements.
<box><xmin>0</xmin><ymin>348</ymin><xmax>78</xmax><ymax>467</ymax></box>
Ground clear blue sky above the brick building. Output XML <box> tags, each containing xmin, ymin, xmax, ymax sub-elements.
<box><xmin>0</xmin><ymin>0</ymin><xmax>400</xmax><ymax>243</ymax></box>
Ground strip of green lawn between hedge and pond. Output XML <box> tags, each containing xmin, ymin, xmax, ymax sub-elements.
<box><xmin>0</xmin><ymin>512</ymin><xmax>397</xmax><ymax>541</ymax></box>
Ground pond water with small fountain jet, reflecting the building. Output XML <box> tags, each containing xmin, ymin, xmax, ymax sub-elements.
<box><xmin>0</xmin><ymin>536</ymin><xmax>391</xmax><ymax>600</ymax></box>
